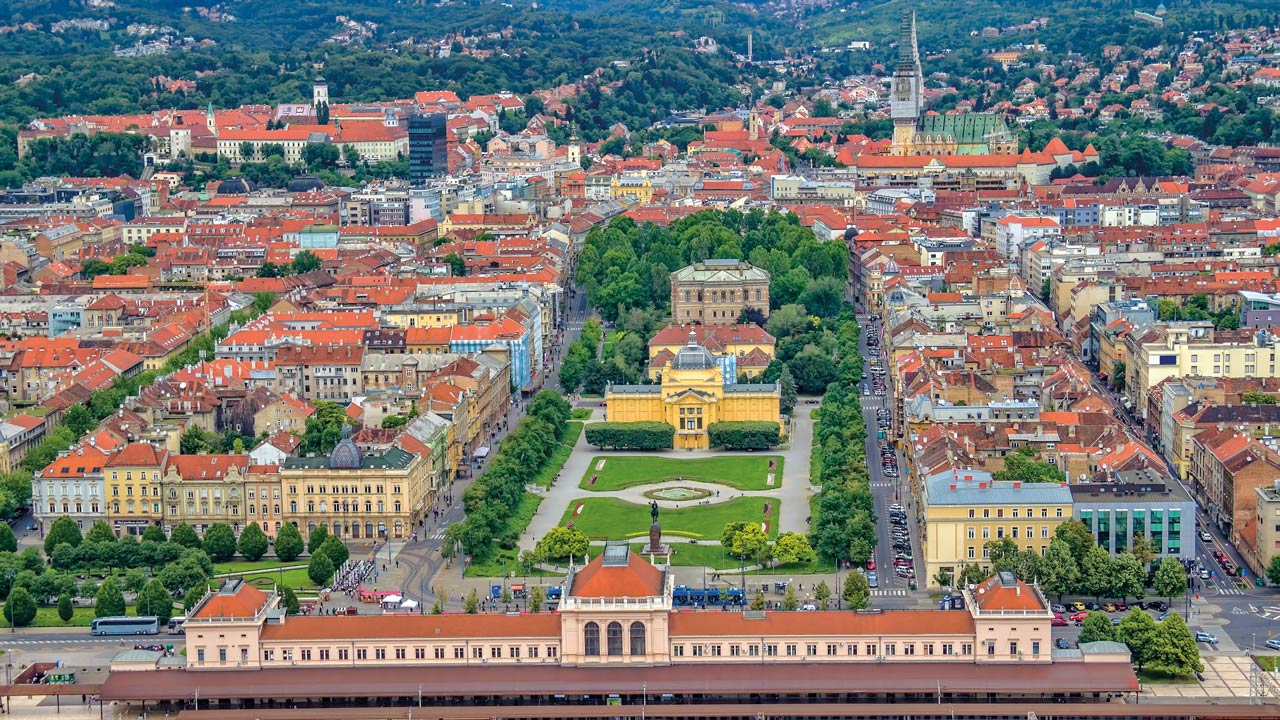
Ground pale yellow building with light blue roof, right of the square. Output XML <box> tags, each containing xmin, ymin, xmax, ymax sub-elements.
<box><xmin>920</xmin><ymin>469</ymin><xmax>1071</xmax><ymax>588</ymax></box>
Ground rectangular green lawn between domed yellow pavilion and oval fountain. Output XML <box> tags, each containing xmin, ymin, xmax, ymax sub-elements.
<box><xmin>579</xmin><ymin>455</ymin><xmax>782</xmax><ymax>492</ymax></box>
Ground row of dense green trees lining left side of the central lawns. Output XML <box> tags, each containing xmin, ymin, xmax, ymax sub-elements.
<box><xmin>442</xmin><ymin>389</ymin><xmax>572</xmax><ymax>560</ymax></box>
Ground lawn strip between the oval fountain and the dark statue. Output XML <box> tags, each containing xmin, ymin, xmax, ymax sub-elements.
<box><xmin>561</xmin><ymin>497</ymin><xmax>782</xmax><ymax>542</ymax></box>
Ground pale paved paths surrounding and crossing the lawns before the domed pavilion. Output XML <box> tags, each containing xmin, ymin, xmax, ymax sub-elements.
<box><xmin>520</xmin><ymin>398</ymin><xmax>817</xmax><ymax>550</ymax></box>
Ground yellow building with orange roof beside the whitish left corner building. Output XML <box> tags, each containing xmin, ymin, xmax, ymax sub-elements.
<box><xmin>102</xmin><ymin>442</ymin><xmax>169</xmax><ymax>536</ymax></box>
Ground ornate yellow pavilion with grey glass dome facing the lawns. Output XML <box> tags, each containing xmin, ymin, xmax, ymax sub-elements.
<box><xmin>604</xmin><ymin>333</ymin><xmax>782</xmax><ymax>450</ymax></box>
